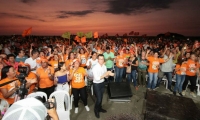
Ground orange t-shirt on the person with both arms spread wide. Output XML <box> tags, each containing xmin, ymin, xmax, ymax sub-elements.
<box><xmin>147</xmin><ymin>57</ymin><xmax>165</xmax><ymax>73</ymax></box>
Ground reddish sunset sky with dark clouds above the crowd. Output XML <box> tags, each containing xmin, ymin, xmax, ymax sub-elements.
<box><xmin>0</xmin><ymin>0</ymin><xmax>200</xmax><ymax>36</ymax></box>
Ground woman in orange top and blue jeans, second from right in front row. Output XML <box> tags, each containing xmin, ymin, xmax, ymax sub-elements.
<box><xmin>173</xmin><ymin>58</ymin><xmax>187</xmax><ymax>96</ymax></box>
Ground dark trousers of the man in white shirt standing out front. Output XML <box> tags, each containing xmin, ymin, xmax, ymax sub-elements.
<box><xmin>93</xmin><ymin>82</ymin><xmax>105</xmax><ymax>112</ymax></box>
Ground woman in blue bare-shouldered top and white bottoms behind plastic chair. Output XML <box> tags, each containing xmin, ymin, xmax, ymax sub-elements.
<box><xmin>54</xmin><ymin>62</ymin><xmax>69</xmax><ymax>92</ymax></box>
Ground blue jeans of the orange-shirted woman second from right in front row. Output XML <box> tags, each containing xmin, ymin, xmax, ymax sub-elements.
<box><xmin>174</xmin><ymin>74</ymin><xmax>185</xmax><ymax>93</ymax></box>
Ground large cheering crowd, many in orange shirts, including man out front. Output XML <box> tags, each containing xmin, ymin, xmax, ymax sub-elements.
<box><xmin>0</xmin><ymin>37</ymin><xmax>200</xmax><ymax>118</ymax></box>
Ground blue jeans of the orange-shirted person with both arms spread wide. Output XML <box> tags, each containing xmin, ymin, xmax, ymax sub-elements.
<box><xmin>147</xmin><ymin>72</ymin><xmax>158</xmax><ymax>89</ymax></box>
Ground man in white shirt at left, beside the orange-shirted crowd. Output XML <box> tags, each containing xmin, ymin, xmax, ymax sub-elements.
<box><xmin>25</xmin><ymin>49</ymin><xmax>39</xmax><ymax>73</ymax></box>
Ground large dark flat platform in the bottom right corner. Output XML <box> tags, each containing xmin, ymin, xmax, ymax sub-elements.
<box><xmin>144</xmin><ymin>90</ymin><xmax>200</xmax><ymax>120</ymax></box>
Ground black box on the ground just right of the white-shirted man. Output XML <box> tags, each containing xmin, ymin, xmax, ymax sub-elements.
<box><xmin>108</xmin><ymin>82</ymin><xmax>133</xmax><ymax>99</ymax></box>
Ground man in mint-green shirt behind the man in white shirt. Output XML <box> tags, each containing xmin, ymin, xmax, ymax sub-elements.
<box><xmin>103</xmin><ymin>47</ymin><xmax>115</xmax><ymax>82</ymax></box>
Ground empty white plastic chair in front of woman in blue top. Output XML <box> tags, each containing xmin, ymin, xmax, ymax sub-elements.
<box><xmin>49</xmin><ymin>90</ymin><xmax>70</xmax><ymax>120</ymax></box>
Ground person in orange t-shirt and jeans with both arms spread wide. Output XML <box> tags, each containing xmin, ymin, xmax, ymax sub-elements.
<box><xmin>146</xmin><ymin>50</ymin><xmax>172</xmax><ymax>90</ymax></box>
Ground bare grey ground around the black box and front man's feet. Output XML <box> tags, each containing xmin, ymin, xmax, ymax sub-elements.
<box><xmin>70</xmin><ymin>83</ymin><xmax>200</xmax><ymax>120</ymax></box>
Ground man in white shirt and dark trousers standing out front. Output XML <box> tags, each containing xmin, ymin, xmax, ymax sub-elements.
<box><xmin>92</xmin><ymin>54</ymin><xmax>114</xmax><ymax>118</ymax></box>
